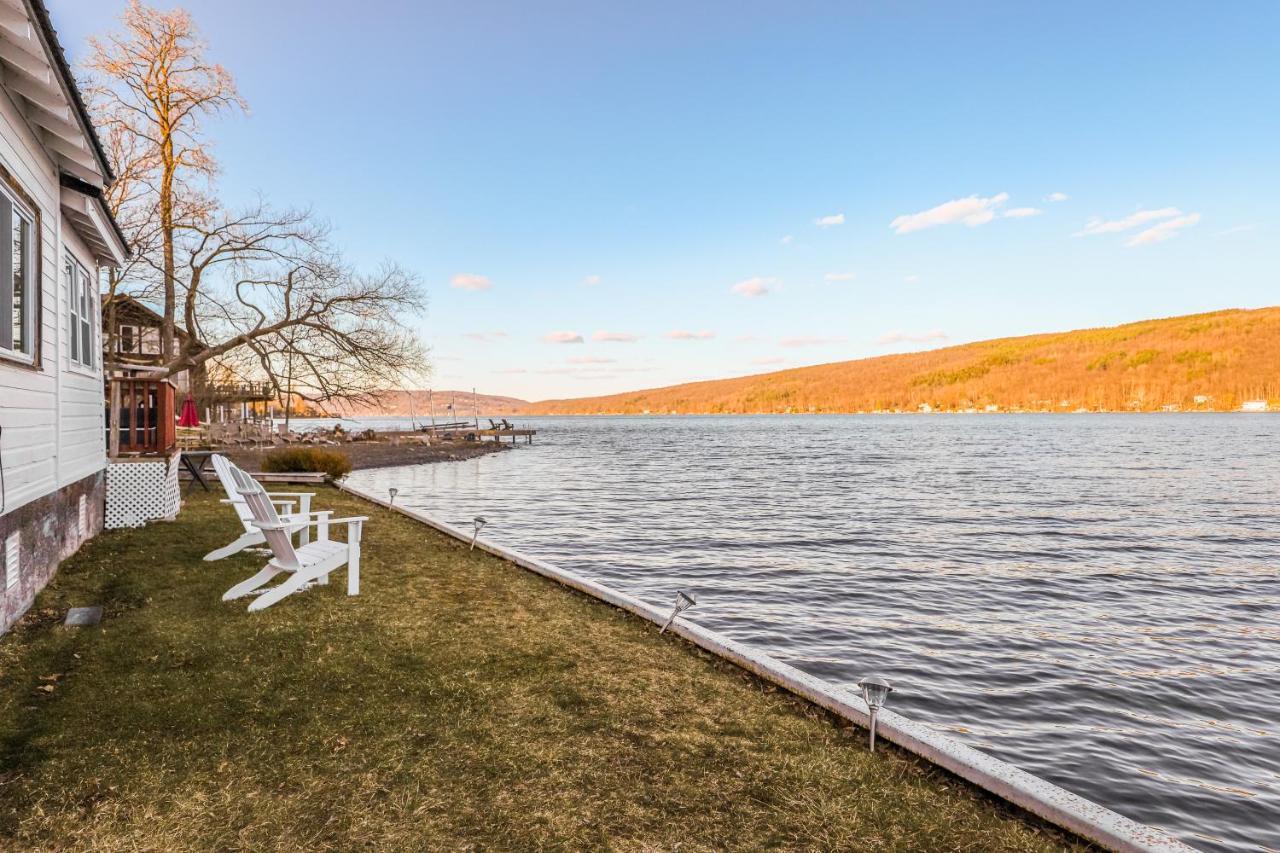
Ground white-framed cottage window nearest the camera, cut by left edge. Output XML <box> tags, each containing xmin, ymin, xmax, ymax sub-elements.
<box><xmin>0</xmin><ymin>186</ymin><xmax>38</xmax><ymax>361</ymax></box>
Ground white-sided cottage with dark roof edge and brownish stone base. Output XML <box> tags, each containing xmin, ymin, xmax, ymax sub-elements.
<box><xmin>0</xmin><ymin>0</ymin><xmax>128</xmax><ymax>633</ymax></box>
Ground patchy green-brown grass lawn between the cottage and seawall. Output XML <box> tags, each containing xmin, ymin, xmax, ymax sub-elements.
<box><xmin>0</xmin><ymin>488</ymin><xmax>1079</xmax><ymax>850</ymax></box>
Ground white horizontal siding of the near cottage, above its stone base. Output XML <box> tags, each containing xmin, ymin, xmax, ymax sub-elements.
<box><xmin>0</xmin><ymin>86</ymin><xmax>106</xmax><ymax>512</ymax></box>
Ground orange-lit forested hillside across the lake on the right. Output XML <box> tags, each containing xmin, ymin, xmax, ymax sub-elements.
<box><xmin>526</xmin><ymin>307</ymin><xmax>1280</xmax><ymax>414</ymax></box>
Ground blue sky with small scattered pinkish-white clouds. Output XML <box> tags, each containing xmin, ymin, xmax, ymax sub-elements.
<box><xmin>49</xmin><ymin>0</ymin><xmax>1280</xmax><ymax>398</ymax></box>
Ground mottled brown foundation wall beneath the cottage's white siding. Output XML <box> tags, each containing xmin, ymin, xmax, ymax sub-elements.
<box><xmin>0</xmin><ymin>471</ymin><xmax>106</xmax><ymax>634</ymax></box>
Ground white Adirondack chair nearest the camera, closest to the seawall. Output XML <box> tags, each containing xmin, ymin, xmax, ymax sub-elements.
<box><xmin>223</xmin><ymin>469</ymin><xmax>369</xmax><ymax>612</ymax></box>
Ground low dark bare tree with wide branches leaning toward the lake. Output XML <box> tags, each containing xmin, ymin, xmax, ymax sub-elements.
<box><xmin>164</xmin><ymin>204</ymin><xmax>425</xmax><ymax>402</ymax></box>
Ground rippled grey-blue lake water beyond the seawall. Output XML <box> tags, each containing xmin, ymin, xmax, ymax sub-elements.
<box><xmin>351</xmin><ymin>415</ymin><xmax>1280</xmax><ymax>850</ymax></box>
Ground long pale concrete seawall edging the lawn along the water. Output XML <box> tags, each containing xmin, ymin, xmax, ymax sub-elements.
<box><xmin>338</xmin><ymin>483</ymin><xmax>1192</xmax><ymax>852</ymax></box>
